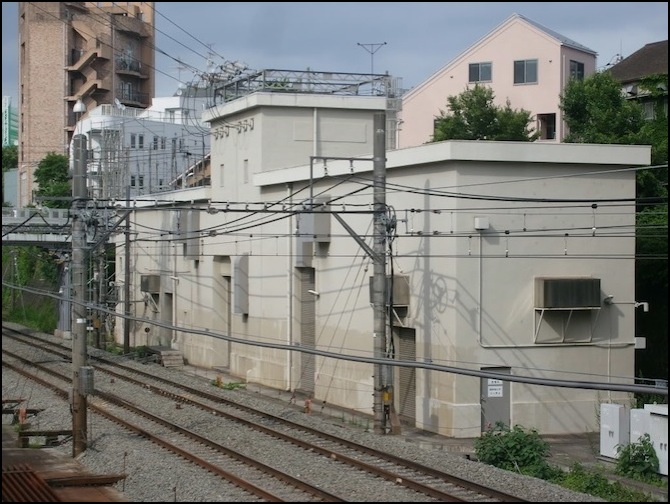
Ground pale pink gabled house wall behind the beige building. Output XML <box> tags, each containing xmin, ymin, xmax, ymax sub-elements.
<box><xmin>398</xmin><ymin>16</ymin><xmax>596</xmax><ymax>148</ymax></box>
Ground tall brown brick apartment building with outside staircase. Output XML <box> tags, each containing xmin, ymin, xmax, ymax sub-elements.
<box><xmin>17</xmin><ymin>2</ymin><xmax>155</xmax><ymax>206</ymax></box>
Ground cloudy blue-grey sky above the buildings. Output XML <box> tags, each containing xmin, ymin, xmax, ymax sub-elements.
<box><xmin>2</xmin><ymin>2</ymin><xmax>668</xmax><ymax>106</ymax></box>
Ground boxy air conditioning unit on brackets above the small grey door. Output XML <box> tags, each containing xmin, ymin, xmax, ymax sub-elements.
<box><xmin>535</xmin><ymin>277</ymin><xmax>602</xmax><ymax>310</ymax></box>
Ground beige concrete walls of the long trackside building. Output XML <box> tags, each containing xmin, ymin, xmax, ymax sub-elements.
<box><xmin>118</xmin><ymin>98</ymin><xmax>649</xmax><ymax>437</ymax></box>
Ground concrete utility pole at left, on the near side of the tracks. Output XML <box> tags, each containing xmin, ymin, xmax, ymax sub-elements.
<box><xmin>71</xmin><ymin>131</ymin><xmax>90</xmax><ymax>457</ymax></box>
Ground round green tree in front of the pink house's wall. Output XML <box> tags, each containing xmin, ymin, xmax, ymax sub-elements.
<box><xmin>431</xmin><ymin>84</ymin><xmax>539</xmax><ymax>142</ymax></box>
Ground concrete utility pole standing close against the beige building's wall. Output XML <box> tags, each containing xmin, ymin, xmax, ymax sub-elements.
<box><xmin>372</xmin><ymin>112</ymin><xmax>393</xmax><ymax>434</ymax></box>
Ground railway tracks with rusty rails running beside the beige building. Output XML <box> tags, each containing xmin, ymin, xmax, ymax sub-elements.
<box><xmin>3</xmin><ymin>329</ymin><xmax>523</xmax><ymax>502</ymax></box>
